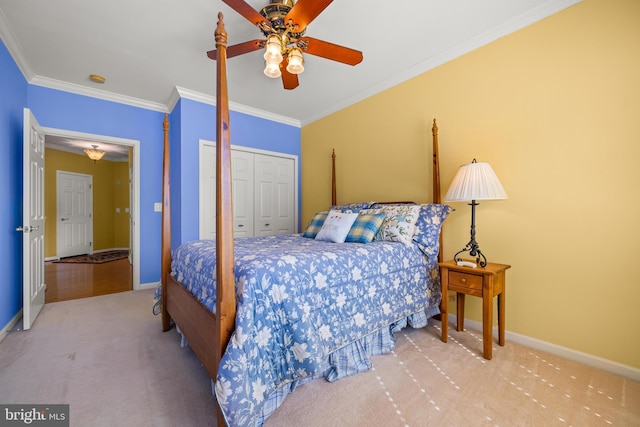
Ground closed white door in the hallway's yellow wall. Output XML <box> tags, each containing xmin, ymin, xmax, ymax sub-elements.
<box><xmin>56</xmin><ymin>171</ymin><xmax>93</xmax><ymax>258</ymax></box>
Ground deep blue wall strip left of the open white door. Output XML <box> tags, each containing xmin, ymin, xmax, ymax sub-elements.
<box><xmin>0</xmin><ymin>40</ymin><xmax>27</xmax><ymax>328</ymax></box>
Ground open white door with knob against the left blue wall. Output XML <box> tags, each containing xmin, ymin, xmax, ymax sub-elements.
<box><xmin>18</xmin><ymin>108</ymin><xmax>46</xmax><ymax>330</ymax></box>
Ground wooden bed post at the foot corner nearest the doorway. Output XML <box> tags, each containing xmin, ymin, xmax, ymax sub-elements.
<box><xmin>161</xmin><ymin>113</ymin><xmax>171</xmax><ymax>331</ymax></box>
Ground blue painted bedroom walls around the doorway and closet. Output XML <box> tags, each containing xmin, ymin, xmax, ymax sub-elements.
<box><xmin>0</xmin><ymin>39</ymin><xmax>301</xmax><ymax>328</ymax></box>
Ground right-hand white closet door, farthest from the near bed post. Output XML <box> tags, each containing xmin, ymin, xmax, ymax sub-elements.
<box><xmin>254</xmin><ymin>154</ymin><xmax>295</xmax><ymax>236</ymax></box>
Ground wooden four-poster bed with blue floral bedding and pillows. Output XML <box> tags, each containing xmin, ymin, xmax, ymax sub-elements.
<box><xmin>161</xmin><ymin>14</ymin><xmax>452</xmax><ymax>426</ymax></box>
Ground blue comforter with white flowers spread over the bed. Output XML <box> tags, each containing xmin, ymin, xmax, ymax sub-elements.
<box><xmin>172</xmin><ymin>235</ymin><xmax>441</xmax><ymax>426</ymax></box>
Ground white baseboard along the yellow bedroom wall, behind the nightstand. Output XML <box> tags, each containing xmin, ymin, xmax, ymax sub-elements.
<box><xmin>449</xmin><ymin>314</ymin><xmax>640</xmax><ymax>381</ymax></box>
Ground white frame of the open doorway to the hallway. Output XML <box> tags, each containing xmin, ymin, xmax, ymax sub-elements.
<box><xmin>42</xmin><ymin>127</ymin><xmax>142</xmax><ymax>291</ymax></box>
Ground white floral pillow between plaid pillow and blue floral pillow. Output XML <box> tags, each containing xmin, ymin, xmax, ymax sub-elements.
<box><xmin>360</xmin><ymin>205</ymin><xmax>421</xmax><ymax>245</ymax></box>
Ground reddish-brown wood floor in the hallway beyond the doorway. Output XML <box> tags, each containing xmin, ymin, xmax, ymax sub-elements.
<box><xmin>44</xmin><ymin>258</ymin><xmax>133</xmax><ymax>304</ymax></box>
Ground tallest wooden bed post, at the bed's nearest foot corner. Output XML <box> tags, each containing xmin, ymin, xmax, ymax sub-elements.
<box><xmin>215</xmin><ymin>13</ymin><xmax>236</xmax><ymax>374</ymax></box>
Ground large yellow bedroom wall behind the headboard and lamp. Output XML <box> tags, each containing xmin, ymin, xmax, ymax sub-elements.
<box><xmin>302</xmin><ymin>0</ymin><xmax>640</xmax><ymax>368</ymax></box>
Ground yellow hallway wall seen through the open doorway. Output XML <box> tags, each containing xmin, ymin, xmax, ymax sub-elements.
<box><xmin>44</xmin><ymin>148</ymin><xmax>129</xmax><ymax>258</ymax></box>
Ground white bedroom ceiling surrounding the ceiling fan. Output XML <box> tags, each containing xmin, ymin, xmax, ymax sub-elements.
<box><xmin>0</xmin><ymin>0</ymin><xmax>579</xmax><ymax>126</ymax></box>
